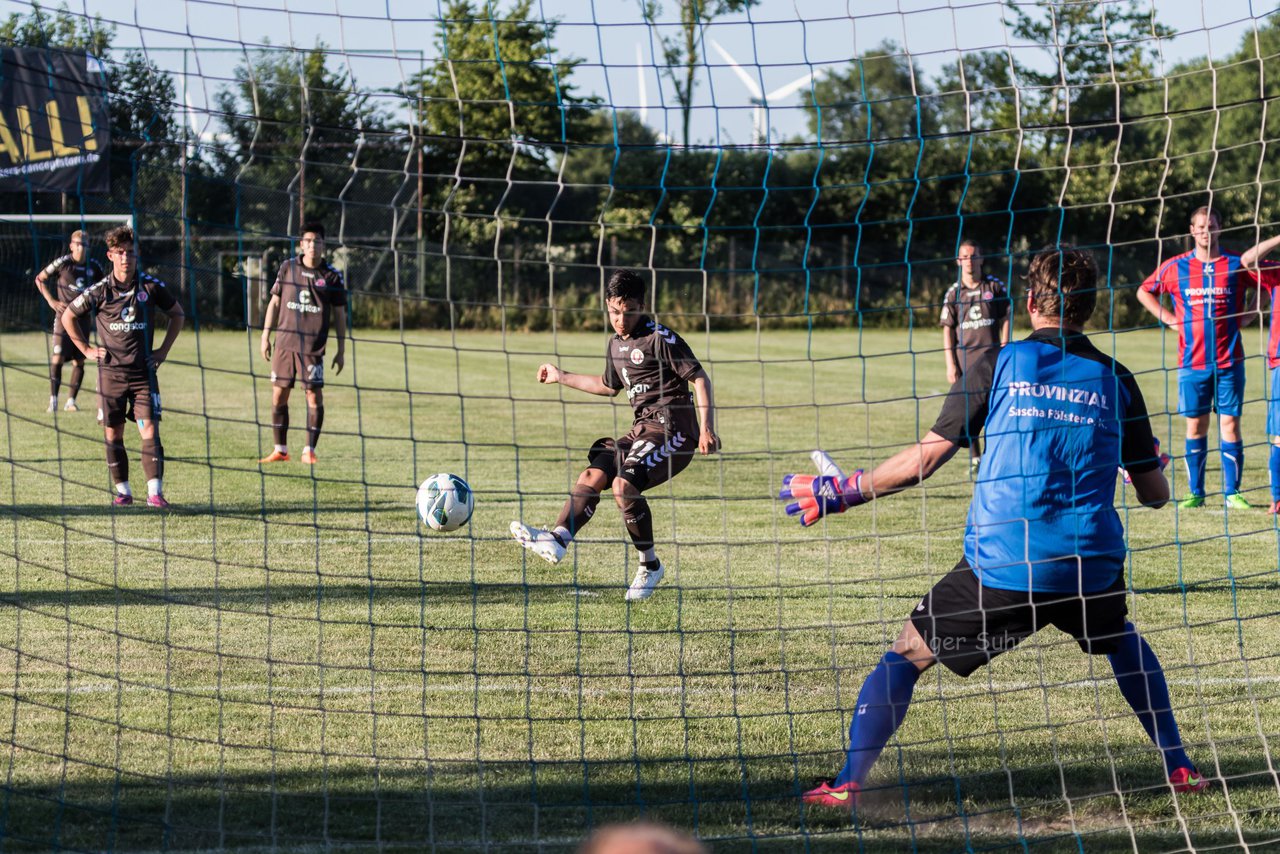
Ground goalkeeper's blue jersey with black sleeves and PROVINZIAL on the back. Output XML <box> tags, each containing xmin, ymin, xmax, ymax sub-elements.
<box><xmin>933</xmin><ymin>328</ymin><xmax>1158</xmax><ymax>593</ymax></box>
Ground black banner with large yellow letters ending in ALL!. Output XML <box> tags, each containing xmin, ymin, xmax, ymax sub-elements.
<box><xmin>0</xmin><ymin>47</ymin><xmax>111</xmax><ymax>193</ymax></box>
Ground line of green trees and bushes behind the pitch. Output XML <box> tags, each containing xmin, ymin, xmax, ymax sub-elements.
<box><xmin>0</xmin><ymin>0</ymin><xmax>1280</xmax><ymax>328</ymax></box>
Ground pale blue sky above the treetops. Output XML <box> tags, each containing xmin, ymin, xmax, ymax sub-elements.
<box><xmin>0</xmin><ymin>0</ymin><xmax>1276</xmax><ymax>145</ymax></box>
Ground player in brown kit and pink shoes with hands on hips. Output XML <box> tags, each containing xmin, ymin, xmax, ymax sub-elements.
<box><xmin>63</xmin><ymin>225</ymin><xmax>184</xmax><ymax>507</ymax></box>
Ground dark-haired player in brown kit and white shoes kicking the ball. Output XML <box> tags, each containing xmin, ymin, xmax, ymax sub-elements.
<box><xmin>511</xmin><ymin>270</ymin><xmax>719</xmax><ymax>600</ymax></box>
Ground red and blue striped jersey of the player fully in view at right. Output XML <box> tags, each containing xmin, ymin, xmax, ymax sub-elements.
<box><xmin>1142</xmin><ymin>252</ymin><xmax>1280</xmax><ymax>370</ymax></box>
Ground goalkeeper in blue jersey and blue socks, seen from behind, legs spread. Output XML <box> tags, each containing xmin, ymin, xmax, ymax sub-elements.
<box><xmin>781</xmin><ymin>250</ymin><xmax>1208</xmax><ymax>808</ymax></box>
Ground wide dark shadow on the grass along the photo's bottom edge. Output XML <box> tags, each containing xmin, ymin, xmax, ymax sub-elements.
<box><xmin>0</xmin><ymin>752</ymin><xmax>1280</xmax><ymax>853</ymax></box>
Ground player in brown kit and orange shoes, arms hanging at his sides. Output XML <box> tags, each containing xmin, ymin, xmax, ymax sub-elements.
<box><xmin>259</xmin><ymin>223</ymin><xmax>347</xmax><ymax>465</ymax></box>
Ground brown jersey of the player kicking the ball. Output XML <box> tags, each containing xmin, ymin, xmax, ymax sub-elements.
<box><xmin>600</xmin><ymin>318</ymin><xmax>703</xmax><ymax>424</ymax></box>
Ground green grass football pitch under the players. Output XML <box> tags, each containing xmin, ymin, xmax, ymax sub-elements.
<box><xmin>0</xmin><ymin>323</ymin><xmax>1280</xmax><ymax>853</ymax></box>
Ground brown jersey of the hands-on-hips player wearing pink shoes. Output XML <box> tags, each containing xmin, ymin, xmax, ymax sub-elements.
<box><xmin>69</xmin><ymin>270</ymin><xmax>177</xmax><ymax>371</ymax></box>
